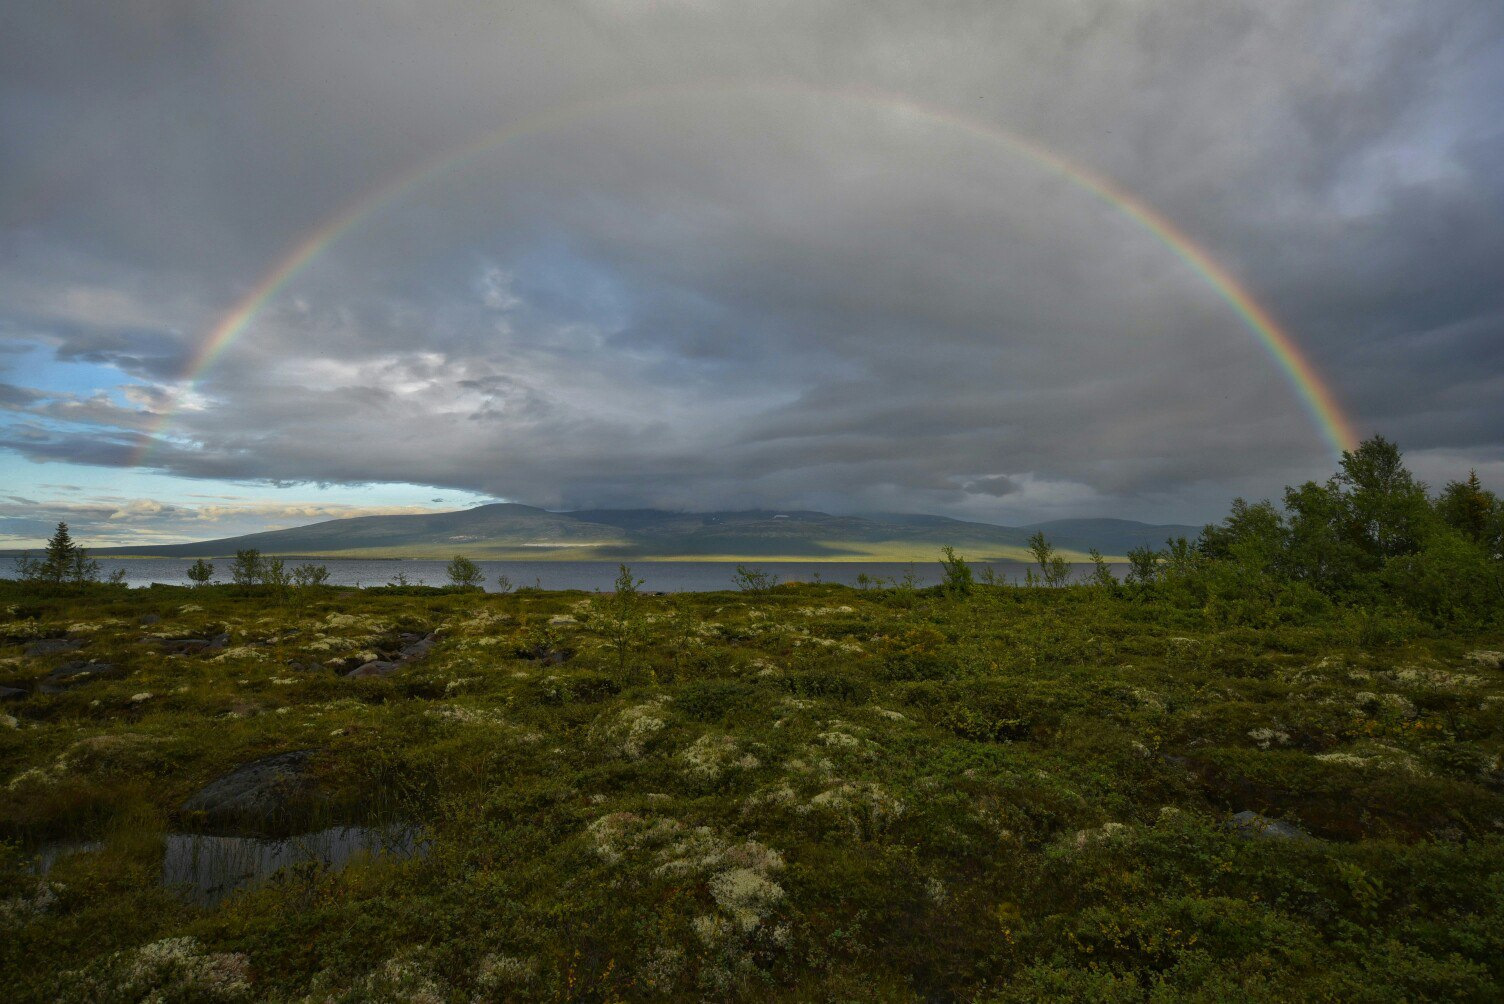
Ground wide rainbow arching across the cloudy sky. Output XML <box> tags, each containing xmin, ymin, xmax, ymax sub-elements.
<box><xmin>134</xmin><ymin>81</ymin><xmax>1358</xmax><ymax>466</ymax></box>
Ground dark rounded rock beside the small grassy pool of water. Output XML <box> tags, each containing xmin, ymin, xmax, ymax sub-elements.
<box><xmin>179</xmin><ymin>750</ymin><xmax>317</xmax><ymax>834</ymax></box>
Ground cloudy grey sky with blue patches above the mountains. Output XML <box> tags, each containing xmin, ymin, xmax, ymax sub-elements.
<box><xmin>0</xmin><ymin>0</ymin><xmax>1504</xmax><ymax>547</ymax></box>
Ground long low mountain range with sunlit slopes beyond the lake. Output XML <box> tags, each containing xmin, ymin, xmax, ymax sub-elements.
<box><xmin>98</xmin><ymin>502</ymin><xmax>1200</xmax><ymax>561</ymax></box>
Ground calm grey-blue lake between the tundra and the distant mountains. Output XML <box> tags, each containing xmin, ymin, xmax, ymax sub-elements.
<box><xmin>11</xmin><ymin>558</ymin><xmax>1122</xmax><ymax>592</ymax></box>
